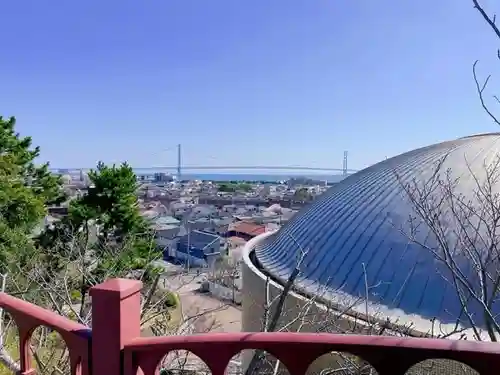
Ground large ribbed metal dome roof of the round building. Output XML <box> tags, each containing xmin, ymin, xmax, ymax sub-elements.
<box><xmin>255</xmin><ymin>133</ymin><xmax>500</xmax><ymax>337</ymax></box>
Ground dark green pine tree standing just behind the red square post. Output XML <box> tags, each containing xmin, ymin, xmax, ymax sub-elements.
<box><xmin>40</xmin><ymin>162</ymin><xmax>157</xmax><ymax>269</ymax></box>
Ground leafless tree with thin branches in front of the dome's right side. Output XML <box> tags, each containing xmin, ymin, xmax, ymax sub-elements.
<box><xmin>398</xmin><ymin>156</ymin><xmax>500</xmax><ymax>341</ymax></box>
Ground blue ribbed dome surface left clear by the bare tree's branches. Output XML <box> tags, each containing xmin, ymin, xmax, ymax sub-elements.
<box><xmin>255</xmin><ymin>134</ymin><xmax>500</xmax><ymax>326</ymax></box>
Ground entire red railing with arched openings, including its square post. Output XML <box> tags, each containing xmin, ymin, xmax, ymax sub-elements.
<box><xmin>0</xmin><ymin>279</ymin><xmax>500</xmax><ymax>375</ymax></box>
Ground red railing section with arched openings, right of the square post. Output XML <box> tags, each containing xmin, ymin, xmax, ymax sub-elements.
<box><xmin>124</xmin><ymin>332</ymin><xmax>500</xmax><ymax>375</ymax></box>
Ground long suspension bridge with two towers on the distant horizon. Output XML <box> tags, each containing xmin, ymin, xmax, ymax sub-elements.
<box><xmin>51</xmin><ymin>144</ymin><xmax>356</xmax><ymax>176</ymax></box>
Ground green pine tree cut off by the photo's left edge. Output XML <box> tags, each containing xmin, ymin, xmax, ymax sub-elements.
<box><xmin>0</xmin><ymin>116</ymin><xmax>65</xmax><ymax>267</ymax></box>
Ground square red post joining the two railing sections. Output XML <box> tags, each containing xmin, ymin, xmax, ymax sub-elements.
<box><xmin>90</xmin><ymin>279</ymin><xmax>142</xmax><ymax>375</ymax></box>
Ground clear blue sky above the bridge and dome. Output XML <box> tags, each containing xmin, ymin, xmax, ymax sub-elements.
<box><xmin>0</xmin><ymin>0</ymin><xmax>500</xmax><ymax>168</ymax></box>
